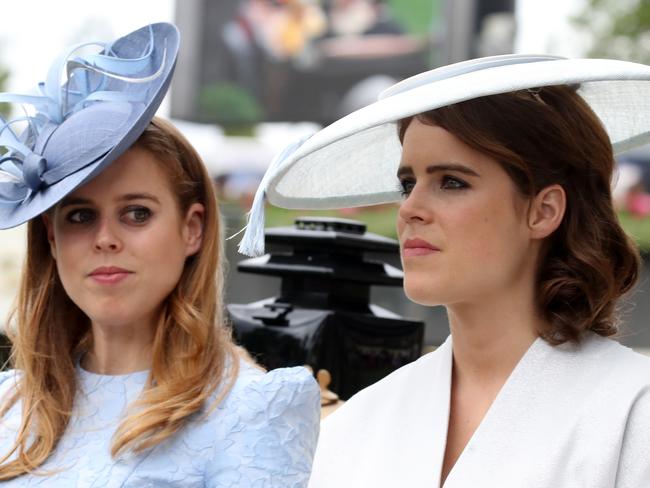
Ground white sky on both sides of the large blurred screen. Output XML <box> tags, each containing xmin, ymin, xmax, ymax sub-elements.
<box><xmin>0</xmin><ymin>0</ymin><xmax>585</xmax><ymax>91</ymax></box>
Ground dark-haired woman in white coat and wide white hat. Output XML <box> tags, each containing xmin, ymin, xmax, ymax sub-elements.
<box><xmin>237</xmin><ymin>56</ymin><xmax>650</xmax><ymax>488</ymax></box>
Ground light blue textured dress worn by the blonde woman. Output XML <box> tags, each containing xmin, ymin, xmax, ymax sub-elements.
<box><xmin>0</xmin><ymin>362</ymin><xmax>320</xmax><ymax>488</ymax></box>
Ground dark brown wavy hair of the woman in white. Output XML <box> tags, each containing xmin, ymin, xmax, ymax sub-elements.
<box><xmin>398</xmin><ymin>86</ymin><xmax>640</xmax><ymax>344</ymax></box>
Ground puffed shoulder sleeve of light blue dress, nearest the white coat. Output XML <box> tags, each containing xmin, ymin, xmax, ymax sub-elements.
<box><xmin>206</xmin><ymin>361</ymin><xmax>320</xmax><ymax>488</ymax></box>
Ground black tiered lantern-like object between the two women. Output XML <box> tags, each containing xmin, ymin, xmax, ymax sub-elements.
<box><xmin>227</xmin><ymin>217</ymin><xmax>424</xmax><ymax>399</ymax></box>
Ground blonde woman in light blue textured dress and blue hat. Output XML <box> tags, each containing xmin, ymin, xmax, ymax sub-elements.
<box><xmin>0</xmin><ymin>24</ymin><xmax>319</xmax><ymax>487</ymax></box>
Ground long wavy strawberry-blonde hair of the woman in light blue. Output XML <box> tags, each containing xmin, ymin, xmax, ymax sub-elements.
<box><xmin>0</xmin><ymin>118</ymin><xmax>242</xmax><ymax>480</ymax></box>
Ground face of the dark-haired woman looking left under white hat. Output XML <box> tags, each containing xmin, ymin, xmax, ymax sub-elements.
<box><xmin>397</xmin><ymin>119</ymin><xmax>536</xmax><ymax>305</ymax></box>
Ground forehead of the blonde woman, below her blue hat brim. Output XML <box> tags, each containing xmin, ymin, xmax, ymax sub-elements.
<box><xmin>69</xmin><ymin>148</ymin><xmax>171</xmax><ymax>199</ymax></box>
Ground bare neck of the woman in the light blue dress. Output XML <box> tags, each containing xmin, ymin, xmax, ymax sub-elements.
<box><xmin>81</xmin><ymin>316</ymin><xmax>155</xmax><ymax>375</ymax></box>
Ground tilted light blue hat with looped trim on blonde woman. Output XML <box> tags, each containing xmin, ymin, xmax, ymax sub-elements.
<box><xmin>0</xmin><ymin>23</ymin><xmax>179</xmax><ymax>229</ymax></box>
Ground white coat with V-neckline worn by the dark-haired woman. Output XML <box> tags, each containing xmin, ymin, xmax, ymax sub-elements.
<box><xmin>309</xmin><ymin>333</ymin><xmax>650</xmax><ymax>488</ymax></box>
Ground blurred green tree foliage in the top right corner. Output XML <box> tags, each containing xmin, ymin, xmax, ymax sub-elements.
<box><xmin>573</xmin><ymin>0</ymin><xmax>650</xmax><ymax>64</ymax></box>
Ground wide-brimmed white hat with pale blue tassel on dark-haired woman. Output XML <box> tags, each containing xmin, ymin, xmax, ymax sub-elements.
<box><xmin>239</xmin><ymin>55</ymin><xmax>650</xmax><ymax>256</ymax></box>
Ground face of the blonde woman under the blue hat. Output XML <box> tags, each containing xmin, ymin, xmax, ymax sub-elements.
<box><xmin>44</xmin><ymin>148</ymin><xmax>203</xmax><ymax>327</ymax></box>
